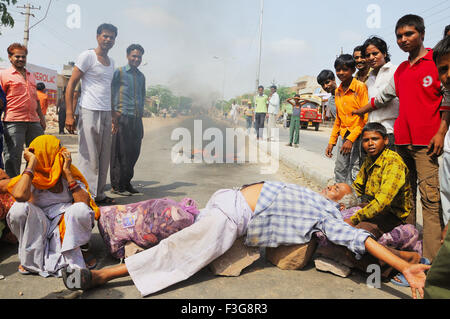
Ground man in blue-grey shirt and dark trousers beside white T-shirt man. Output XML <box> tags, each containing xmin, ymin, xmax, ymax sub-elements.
<box><xmin>110</xmin><ymin>44</ymin><xmax>146</xmax><ymax>196</ymax></box>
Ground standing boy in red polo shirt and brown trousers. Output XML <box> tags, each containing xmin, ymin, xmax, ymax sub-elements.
<box><xmin>353</xmin><ymin>14</ymin><xmax>448</xmax><ymax>261</ymax></box>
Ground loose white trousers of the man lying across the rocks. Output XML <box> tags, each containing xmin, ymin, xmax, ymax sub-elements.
<box><xmin>125</xmin><ymin>190</ymin><xmax>252</xmax><ymax>296</ymax></box>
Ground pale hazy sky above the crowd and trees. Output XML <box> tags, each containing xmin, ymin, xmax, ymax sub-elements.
<box><xmin>0</xmin><ymin>0</ymin><xmax>450</xmax><ymax>103</ymax></box>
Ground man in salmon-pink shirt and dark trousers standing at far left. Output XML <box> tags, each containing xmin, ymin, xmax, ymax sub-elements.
<box><xmin>0</xmin><ymin>43</ymin><xmax>45</xmax><ymax>177</ymax></box>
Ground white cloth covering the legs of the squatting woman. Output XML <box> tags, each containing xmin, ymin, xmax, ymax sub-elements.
<box><xmin>6</xmin><ymin>202</ymin><xmax>94</xmax><ymax>277</ymax></box>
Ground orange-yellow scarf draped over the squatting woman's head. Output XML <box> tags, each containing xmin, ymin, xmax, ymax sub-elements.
<box><xmin>8</xmin><ymin>135</ymin><xmax>100</xmax><ymax>220</ymax></box>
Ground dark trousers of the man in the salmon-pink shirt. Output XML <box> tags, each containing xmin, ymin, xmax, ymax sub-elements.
<box><xmin>3</xmin><ymin>122</ymin><xmax>44</xmax><ymax>178</ymax></box>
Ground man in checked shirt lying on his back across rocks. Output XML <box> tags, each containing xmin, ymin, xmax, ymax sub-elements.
<box><xmin>63</xmin><ymin>182</ymin><xmax>430</xmax><ymax>298</ymax></box>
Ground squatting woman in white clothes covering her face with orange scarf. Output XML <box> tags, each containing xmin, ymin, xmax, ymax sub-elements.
<box><xmin>7</xmin><ymin>135</ymin><xmax>100</xmax><ymax>277</ymax></box>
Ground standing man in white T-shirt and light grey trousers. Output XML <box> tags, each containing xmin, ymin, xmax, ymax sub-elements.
<box><xmin>66</xmin><ymin>24</ymin><xmax>117</xmax><ymax>205</ymax></box>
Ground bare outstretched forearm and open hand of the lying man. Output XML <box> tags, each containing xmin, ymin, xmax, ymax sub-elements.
<box><xmin>364</xmin><ymin>237</ymin><xmax>431</xmax><ymax>299</ymax></box>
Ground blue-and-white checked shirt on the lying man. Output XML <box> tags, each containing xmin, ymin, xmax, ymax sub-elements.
<box><xmin>245</xmin><ymin>182</ymin><xmax>372</xmax><ymax>259</ymax></box>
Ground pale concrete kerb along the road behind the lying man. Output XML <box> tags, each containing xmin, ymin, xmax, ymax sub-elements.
<box><xmin>216</xmin><ymin>118</ymin><xmax>334</xmax><ymax>188</ymax></box>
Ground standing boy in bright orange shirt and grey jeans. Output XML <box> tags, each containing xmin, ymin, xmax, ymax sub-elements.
<box><xmin>325</xmin><ymin>54</ymin><xmax>369</xmax><ymax>185</ymax></box>
